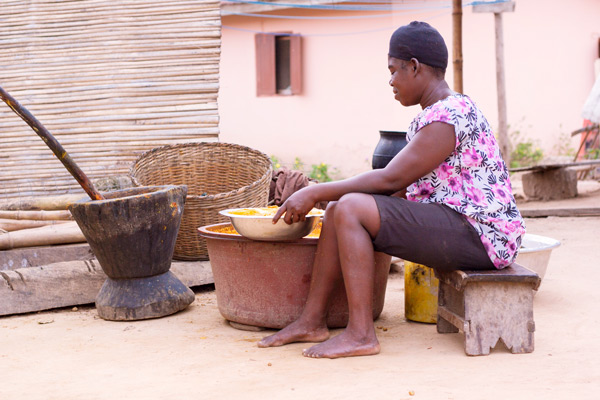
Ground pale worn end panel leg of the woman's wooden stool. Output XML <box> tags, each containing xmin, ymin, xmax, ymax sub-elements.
<box><xmin>464</xmin><ymin>282</ymin><xmax>535</xmax><ymax>356</ymax></box>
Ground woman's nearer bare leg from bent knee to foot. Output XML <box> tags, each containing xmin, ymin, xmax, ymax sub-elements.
<box><xmin>303</xmin><ymin>193</ymin><xmax>381</xmax><ymax>358</ymax></box>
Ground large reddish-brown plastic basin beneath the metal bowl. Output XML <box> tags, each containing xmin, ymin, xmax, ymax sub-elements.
<box><xmin>199</xmin><ymin>223</ymin><xmax>391</xmax><ymax>329</ymax></box>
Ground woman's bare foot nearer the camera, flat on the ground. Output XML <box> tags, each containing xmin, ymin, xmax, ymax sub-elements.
<box><xmin>302</xmin><ymin>330</ymin><xmax>380</xmax><ymax>358</ymax></box>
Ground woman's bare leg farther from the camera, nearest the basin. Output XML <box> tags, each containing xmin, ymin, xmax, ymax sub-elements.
<box><xmin>258</xmin><ymin>202</ymin><xmax>342</xmax><ymax>347</ymax></box>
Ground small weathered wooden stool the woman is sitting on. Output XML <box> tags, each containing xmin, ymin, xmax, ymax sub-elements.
<box><xmin>436</xmin><ymin>263</ymin><xmax>541</xmax><ymax>356</ymax></box>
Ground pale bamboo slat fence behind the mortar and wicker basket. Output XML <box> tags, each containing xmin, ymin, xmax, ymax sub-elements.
<box><xmin>0</xmin><ymin>0</ymin><xmax>221</xmax><ymax>199</ymax></box>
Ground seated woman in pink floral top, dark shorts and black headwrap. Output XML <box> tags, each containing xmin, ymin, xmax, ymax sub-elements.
<box><xmin>258</xmin><ymin>21</ymin><xmax>525</xmax><ymax>358</ymax></box>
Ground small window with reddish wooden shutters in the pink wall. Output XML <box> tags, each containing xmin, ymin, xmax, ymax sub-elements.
<box><xmin>255</xmin><ymin>33</ymin><xmax>302</xmax><ymax>96</ymax></box>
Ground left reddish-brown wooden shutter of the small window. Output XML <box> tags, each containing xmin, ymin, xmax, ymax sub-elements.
<box><xmin>254</xmin><ymin>33</ymin><xmax>277</xmax><ymax>96</ymax></box>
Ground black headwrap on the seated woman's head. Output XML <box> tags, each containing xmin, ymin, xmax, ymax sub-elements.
<box><xmin>388</xmin><ymin>21</ymin><xmax>448</xmax><ymax>71</ymax></box>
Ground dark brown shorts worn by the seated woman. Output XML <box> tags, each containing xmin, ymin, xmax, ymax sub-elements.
<box><xmin>373</xmin><ymin>195</ymin><xmax>495</xmax><ymax>271</ymax></box>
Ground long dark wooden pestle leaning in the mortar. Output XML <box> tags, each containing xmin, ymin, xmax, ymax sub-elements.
<box><xmin>0</xmin><ymin>87</ymin><xmax>104</xmax><ymax>200</ymax></box>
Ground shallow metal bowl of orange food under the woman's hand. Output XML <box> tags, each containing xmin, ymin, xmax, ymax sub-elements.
<box><xmin>219</xmin><ymin>208</ymin><xmax>322</xmax><ymax>241</ymax></box>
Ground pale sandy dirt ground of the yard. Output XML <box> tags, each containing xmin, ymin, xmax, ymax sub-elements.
<box><xmin>0</xmin><ymin>182</ymin><xmax>600</xmax><ymax>400</ymax></box>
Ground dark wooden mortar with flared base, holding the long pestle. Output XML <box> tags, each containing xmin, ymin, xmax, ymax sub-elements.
<box><xmin>69</xmin><ymin>186</ymin><xmax>194</xmax><ymax>321</ymax></box>
